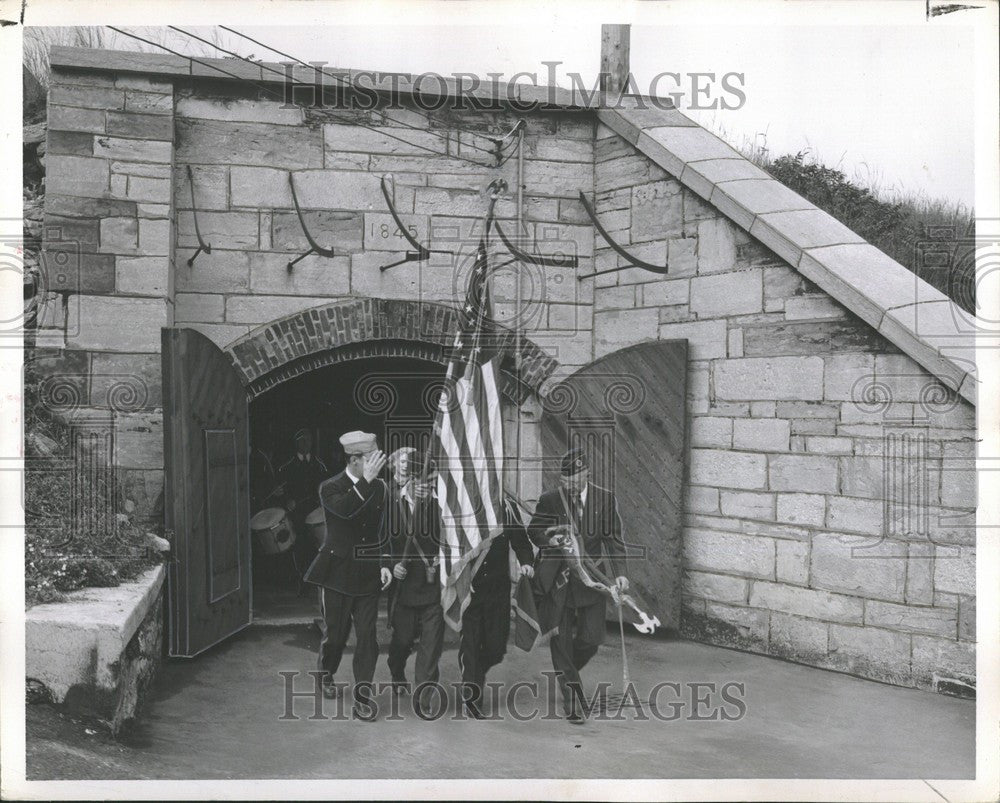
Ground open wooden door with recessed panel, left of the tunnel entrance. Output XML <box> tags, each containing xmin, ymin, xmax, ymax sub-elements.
<box><xmin>161</xmin><ymin>328</ymin><xmax>251</xmax><ymax>657</ymax></box>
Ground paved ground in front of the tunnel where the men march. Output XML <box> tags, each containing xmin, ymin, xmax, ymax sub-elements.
<box><xmin>28</xmin><ymin>625</ymin><xmax>975</xmax><ymax>779</ymax></box>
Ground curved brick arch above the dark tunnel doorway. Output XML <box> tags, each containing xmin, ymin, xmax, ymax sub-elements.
<box><xmin>225</xmin><ymin>298</ymin><xmax>558</xmax><ymax>398</ymax></box>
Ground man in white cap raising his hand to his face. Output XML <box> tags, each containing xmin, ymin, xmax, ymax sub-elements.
<box><xmin>305</xmin><ymin>432</ymin><xmax>392</xmax><ymax>719</ymax></box>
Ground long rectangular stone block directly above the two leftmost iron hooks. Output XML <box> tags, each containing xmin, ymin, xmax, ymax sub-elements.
<box><xmin>175</xmin><ymin>119</ymin><xmax>324</xmax><ymax>169</ymax></box>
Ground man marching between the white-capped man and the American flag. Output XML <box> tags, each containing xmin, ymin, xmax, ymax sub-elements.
<box><xmin>389</xmin><ymin>451</ymin><xmax>444</xmax><ymax>710</ymax></box>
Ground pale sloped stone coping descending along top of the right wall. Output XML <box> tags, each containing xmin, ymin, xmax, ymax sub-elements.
<box><xmin>612</xmin><ymin>108</ymin><xmax>977</xmax><ymax>404</ymax></box>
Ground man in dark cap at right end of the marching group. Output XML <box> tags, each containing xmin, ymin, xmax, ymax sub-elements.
<box><xmin>529</xmin><ymin>448</ymin><xmax>628</xmax><ymax>722</ymax></box>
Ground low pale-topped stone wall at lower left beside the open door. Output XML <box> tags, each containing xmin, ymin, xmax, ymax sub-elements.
<box><xmin>24</xmin><ymin>564</ymin><xmax>166</xmax><ymax>731</ymax></box>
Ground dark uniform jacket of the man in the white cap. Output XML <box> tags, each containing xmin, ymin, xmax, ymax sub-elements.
<box><xmin>304</xmin><ymin>470</ymin><xmax>390</xmax><ymax>596</ymax></box>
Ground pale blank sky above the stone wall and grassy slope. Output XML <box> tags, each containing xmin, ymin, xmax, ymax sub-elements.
<box><xmin>56</xmin><ymin>15</ymin><xmax>975</xmax><ymax>207</ymax></box>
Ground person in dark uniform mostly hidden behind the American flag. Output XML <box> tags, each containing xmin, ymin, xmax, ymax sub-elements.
<box><xmin>458</xmin><ymin>498</ymin><xmax>535</xmax><ymax>719</ymax></box>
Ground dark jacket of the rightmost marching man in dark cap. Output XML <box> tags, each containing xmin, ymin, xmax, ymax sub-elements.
<box><xmin>528</xmin><ymin>483</ymin><xmax>625</xmax><ymax>607</ymax></box>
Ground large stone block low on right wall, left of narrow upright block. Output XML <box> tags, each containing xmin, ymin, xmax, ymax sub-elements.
<box><xmin>810</xmin><ymin>532</ymin><xmax>907</xmax><ymax>602</ymax></box>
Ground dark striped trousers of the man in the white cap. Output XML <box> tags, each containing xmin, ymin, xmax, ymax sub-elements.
<box><xmin>318</xmin><ymin>588</ymin><xmax>379</xmax><ymax>697</ymax></box>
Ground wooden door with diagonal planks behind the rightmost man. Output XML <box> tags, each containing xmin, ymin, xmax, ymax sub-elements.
<box><xmin>542</xmin><ymin>340</ymin><xmax>687</xmax><ymax>630</ymax></box>
